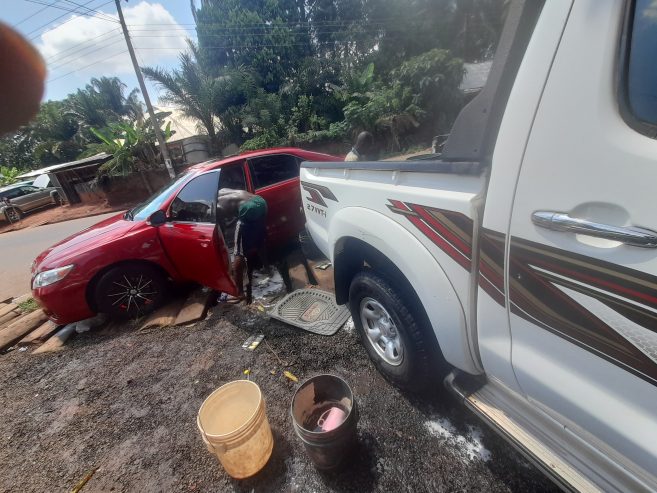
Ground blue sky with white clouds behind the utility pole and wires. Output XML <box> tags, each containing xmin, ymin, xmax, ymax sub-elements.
<box><xmin>0</xmin><ymin>0</ymin><xmax>196</xmax><ymax>103</ymax></box>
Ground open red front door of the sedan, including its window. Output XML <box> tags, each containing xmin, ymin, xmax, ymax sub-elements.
<box><xmin>158</xmin><ymin>170</ymin><xmax>237</xmax><ymax>295</ymax></box>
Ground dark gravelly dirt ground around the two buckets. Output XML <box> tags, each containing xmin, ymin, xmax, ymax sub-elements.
<box><xmin>0</xmin><ymin>296</ymin><xmax>554</xmax><ymax>492</ymax></box>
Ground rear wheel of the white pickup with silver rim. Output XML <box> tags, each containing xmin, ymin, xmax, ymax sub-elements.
<box><xmin>349</xmin><ymin>271</ymin><xmax>436</xmax><ymax>391</ymax></box>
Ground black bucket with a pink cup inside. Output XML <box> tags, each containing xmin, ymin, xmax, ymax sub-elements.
<box><xmin>291</xmin><ymin>375</ymin><xmax>358</xmax><ymax>471</ymax></box>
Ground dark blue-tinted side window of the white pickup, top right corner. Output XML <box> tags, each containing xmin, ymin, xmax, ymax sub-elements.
<box><xmin>627</xmin><ymin>0</ymin><xmax>657</xmax><ymax>129</ymax></box>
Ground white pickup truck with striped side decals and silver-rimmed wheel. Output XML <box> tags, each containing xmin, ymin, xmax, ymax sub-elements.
<box><xmin>301</xmin><ymin>0</ymin><xmax>657</xmax><ymax>491</ymax></box>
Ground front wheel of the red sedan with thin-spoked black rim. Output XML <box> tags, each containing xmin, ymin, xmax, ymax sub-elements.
<box><xmin>94</xmin><ymin>265</ymin><xmax>169</xmax><ymax>320</ymax></box>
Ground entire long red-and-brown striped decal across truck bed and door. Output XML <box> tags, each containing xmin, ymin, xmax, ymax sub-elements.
<box><xmin>387</xmin><ymin>199</ymin><xmax>657</xmax><ymax>385</ymax></box>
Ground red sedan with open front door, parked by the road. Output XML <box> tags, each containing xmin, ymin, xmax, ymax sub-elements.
<box><xmin>32</xmin><ymin>148</ymin><xmax>339</xmax><ymax>324</ymax></box>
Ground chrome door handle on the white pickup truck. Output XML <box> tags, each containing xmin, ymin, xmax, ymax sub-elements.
<box><xmin>532</xmin><ymin>211</ymin><xmax>657</xmax><ymax>248</ymax></box>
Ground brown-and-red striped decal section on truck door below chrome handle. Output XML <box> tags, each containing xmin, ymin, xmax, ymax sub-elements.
<box><xmin>509</xmin><ymin>237</ymin><xmax>657</xmax><ymax>385</ymax></box>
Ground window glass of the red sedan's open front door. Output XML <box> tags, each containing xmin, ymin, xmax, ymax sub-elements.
<box><xmin>170</xmin><ymin>172</ymin><xmax>219</xmax><ymax>223</ymax></box>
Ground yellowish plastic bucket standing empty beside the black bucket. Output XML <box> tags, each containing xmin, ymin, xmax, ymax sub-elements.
<box><xmin>196</xmin><ymin>380</ymin><xmax>274</xmax><ymax>479</ymax></box>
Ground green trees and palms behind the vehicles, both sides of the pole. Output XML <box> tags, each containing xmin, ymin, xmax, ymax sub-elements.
<box><xmin>0</xmin><ymin>0</ymin><xmax>508</xmax><ymax>169</ymax></box>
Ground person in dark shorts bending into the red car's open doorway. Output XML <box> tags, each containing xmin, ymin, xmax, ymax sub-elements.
<box><xmin>217</xmin><ymin>188</ymin><xmax>267</xmax><ymax>304</ymax></box>
